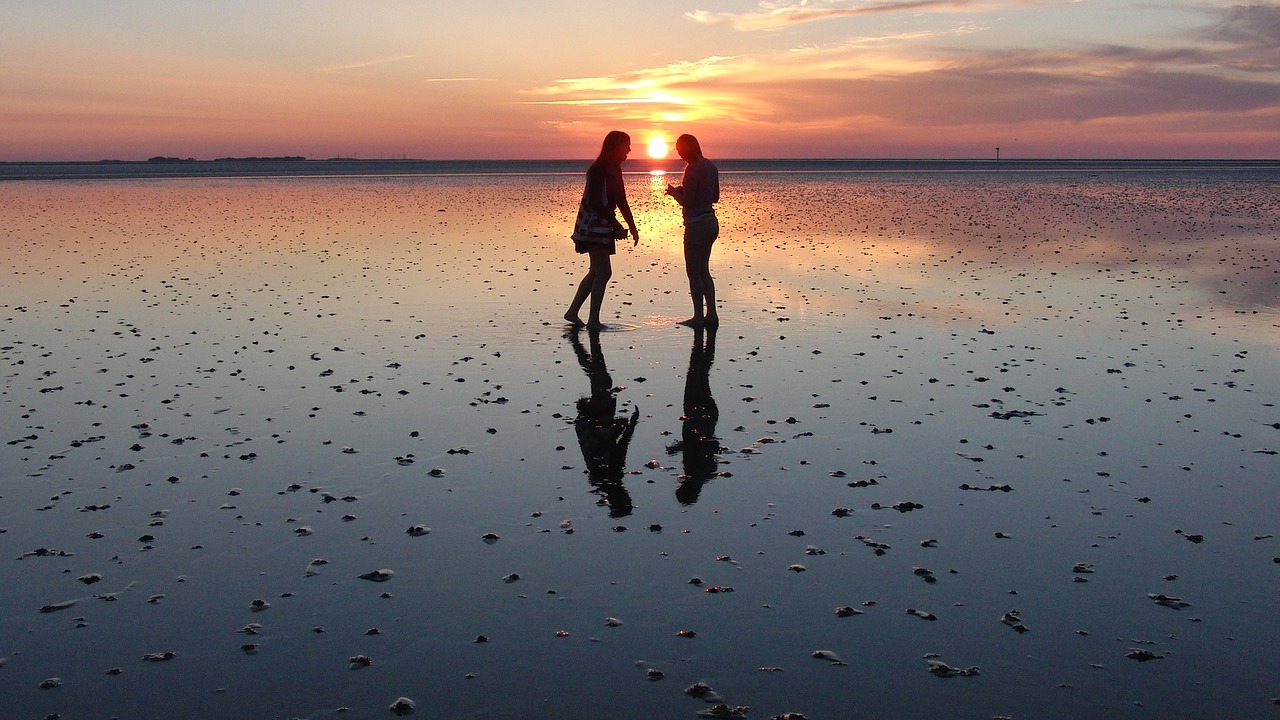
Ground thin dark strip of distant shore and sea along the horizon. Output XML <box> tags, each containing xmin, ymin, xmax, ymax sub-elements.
<box><xmin>0</xmin><ymin>156</ymin><xmax>1280</xmax><ymax>181</ymax></box>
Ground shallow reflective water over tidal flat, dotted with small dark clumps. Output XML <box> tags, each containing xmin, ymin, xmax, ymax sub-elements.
<box><xmin>0</xmin><ymin>170</ymin><xmax>1280</xmax><ymax>719</ymax></box>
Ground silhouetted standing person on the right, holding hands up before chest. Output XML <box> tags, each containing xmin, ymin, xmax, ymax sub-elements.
<box><xmin>667</xmin><ymin>135</ymin><xmax>719</xmax><ymax>325</ymax></box>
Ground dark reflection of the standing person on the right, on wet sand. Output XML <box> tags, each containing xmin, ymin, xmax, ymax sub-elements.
<box><xmin>667</xmin><ymin>327</ymin><xmax>721</xmax><ymax>505</ymax></box>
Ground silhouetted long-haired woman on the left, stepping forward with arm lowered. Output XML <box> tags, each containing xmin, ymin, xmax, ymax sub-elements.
<box><xmin>564</xmin><ymin>131</ymin><xmax>640</xmax><ymax>329</ymax></box>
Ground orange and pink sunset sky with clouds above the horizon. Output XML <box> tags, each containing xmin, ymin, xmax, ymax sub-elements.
<box><xmin>0</xmin><ymin>0</ymin><xmax>1280</xmax><ymax>160</ymax></box>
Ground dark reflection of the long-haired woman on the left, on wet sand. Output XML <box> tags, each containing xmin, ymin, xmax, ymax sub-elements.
<box><xmin>568</xmin><ymin>332</ymin><xmax>640</xmax><ymax>518</ymax></box>
